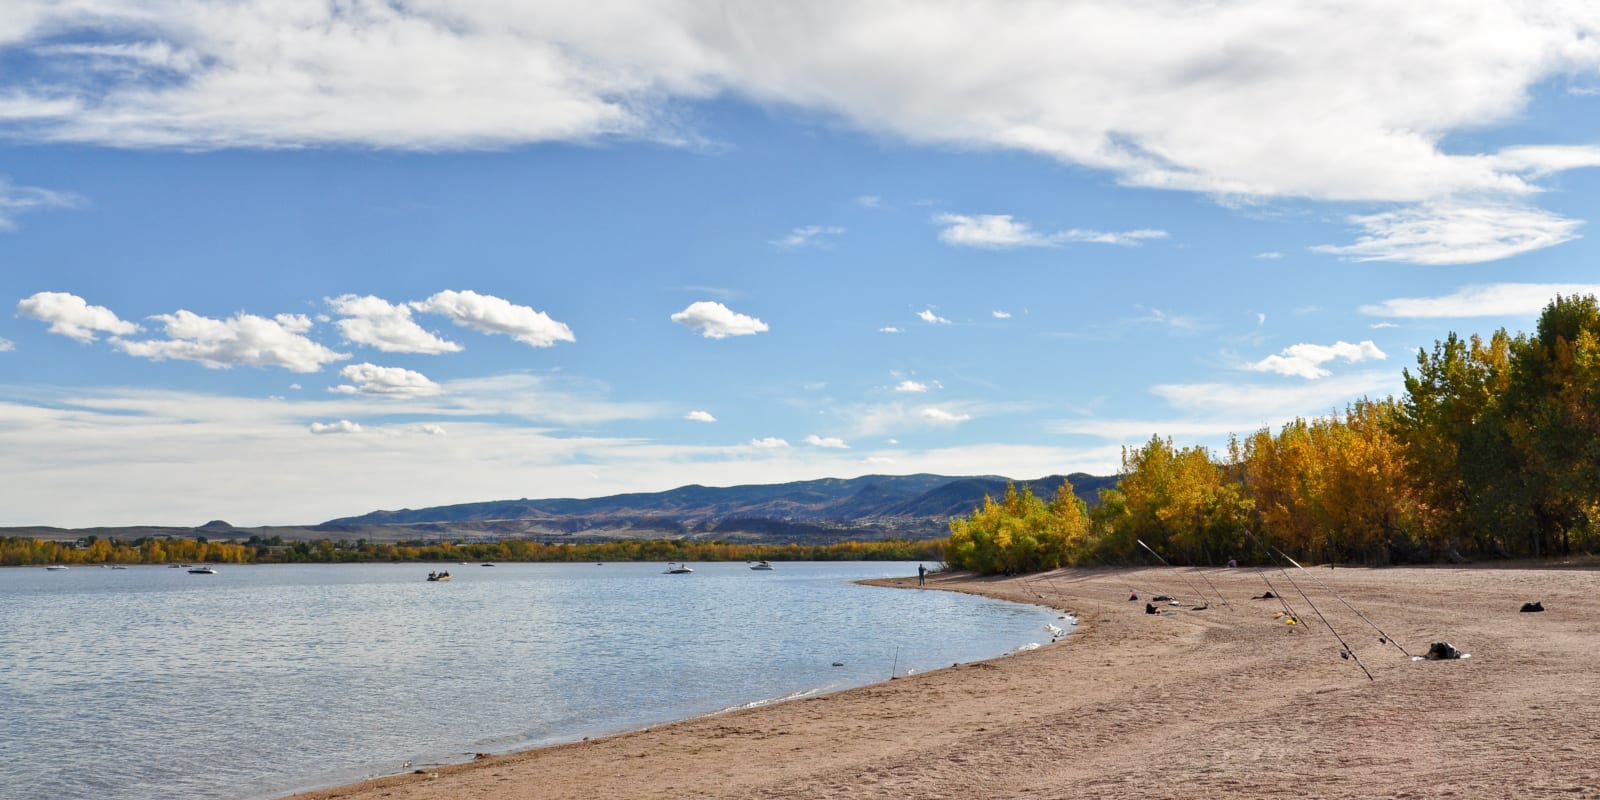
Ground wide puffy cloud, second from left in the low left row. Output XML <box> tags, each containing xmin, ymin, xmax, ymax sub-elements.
<box><xmin>112</xmin><ymin>310</ymin><xmax>350</xmax><ymax>373</ymax></box>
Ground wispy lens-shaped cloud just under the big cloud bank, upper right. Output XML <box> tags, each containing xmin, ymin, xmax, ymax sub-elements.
<box><xmin>1312</xmin><ymin>203</ymin><xmax>1582</xmax><ymax>264</ymax></box>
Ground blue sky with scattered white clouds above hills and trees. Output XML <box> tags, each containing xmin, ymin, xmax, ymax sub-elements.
<box><xmin>0</xmin><ymin>0</ymin><xmax>1600</xmax><ymax>526</ymax></box>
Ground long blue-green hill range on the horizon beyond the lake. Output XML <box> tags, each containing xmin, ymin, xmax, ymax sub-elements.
<box><xmin>318</xmin><ymin>472</ymin><xmax>1117</xmax><ymax>542</ymax></box>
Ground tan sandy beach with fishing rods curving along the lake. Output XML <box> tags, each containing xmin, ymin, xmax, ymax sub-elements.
<box><xmin>296</xmin><ymin>568</ymin><xmax>1600</xmax><ymax>800</ymax></box>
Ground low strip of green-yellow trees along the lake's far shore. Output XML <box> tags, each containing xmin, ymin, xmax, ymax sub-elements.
<box><xmin>0</xmin><ymin>536</ymin><xmax>944</xmax><ymax>566</ymax></box>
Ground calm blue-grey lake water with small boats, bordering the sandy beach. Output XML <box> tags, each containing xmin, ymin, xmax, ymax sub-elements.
<box><xmin>0</xmin><ymin>562</ymin><xmax>1066</xmax><ymax>800</ymax></box>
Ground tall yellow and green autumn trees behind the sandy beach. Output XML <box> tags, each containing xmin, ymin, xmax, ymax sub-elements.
<box><xmin>946</xmin><ymin>296</ymin><xmax>1600</xmax><ymax>573</ymax></box>
